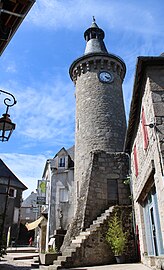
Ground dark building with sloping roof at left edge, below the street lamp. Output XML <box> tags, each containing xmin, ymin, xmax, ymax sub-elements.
<box><xmin>0</xmin><ymin>159</ymin><xmax>27</xmax><ymax>247</ymax></box>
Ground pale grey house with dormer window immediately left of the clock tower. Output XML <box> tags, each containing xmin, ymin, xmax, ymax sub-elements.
<box><xmin>42</xmin><ymin>147</ymin><xmax>74</xmax><ymax>250</ymax></box>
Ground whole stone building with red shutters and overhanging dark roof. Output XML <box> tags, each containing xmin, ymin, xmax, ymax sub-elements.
<box><xmin>125</xmin><ymin>54</ymin><xmax>164</xmax><ymax>269</ymax></box>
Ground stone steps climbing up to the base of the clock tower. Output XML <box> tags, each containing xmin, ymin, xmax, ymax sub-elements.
<box><xmin>40</xmin><ymin>206</ymin><xmax>114</xmax><ymax>270</ymax></box>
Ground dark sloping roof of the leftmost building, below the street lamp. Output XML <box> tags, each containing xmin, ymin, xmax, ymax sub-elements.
<box><xmin>0</xmin><ymin>159</ymin><xmax>27</xmax><ymax>190</ymax></box>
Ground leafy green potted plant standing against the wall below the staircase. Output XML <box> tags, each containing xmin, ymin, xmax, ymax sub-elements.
<box><xmin>106</xmin><ymin>213</ymin><xmax>127</xmax><ymax>263</ymax></box>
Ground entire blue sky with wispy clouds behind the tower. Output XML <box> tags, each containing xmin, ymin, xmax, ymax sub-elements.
<box><xmin>0</xmin><ymin>0</ymin><xmax>164</xmax><ymax>197</ymax></box>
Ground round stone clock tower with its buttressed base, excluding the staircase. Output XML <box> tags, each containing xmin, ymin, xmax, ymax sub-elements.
<box><xmin>62</xmin><ymin>20</ymin><xmax>130</xmax><ymax>253</ymax></box>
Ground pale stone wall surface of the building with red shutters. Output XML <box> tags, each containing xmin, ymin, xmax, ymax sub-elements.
<box><xmin>131</xmin><ymin>66</ymin><xmax>164</xmax><ymax>263</ymax></box>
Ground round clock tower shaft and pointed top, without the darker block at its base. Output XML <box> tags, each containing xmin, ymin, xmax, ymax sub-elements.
<box><xmin>70</xmin><ymin>19</ymin><xmax>126</xmax><ymax>209</ymax></box>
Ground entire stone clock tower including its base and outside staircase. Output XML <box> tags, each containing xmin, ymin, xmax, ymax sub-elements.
<box><xmin>49</xmin><ymin>19</ymin><xmax>135</xmax><ymax>270</ymax></box>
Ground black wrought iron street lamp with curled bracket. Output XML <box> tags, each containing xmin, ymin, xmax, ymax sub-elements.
<box><xmin>0</xmin><ymin>89</ymin><xmax>17</xmax><ymax>142</ymax></box>
